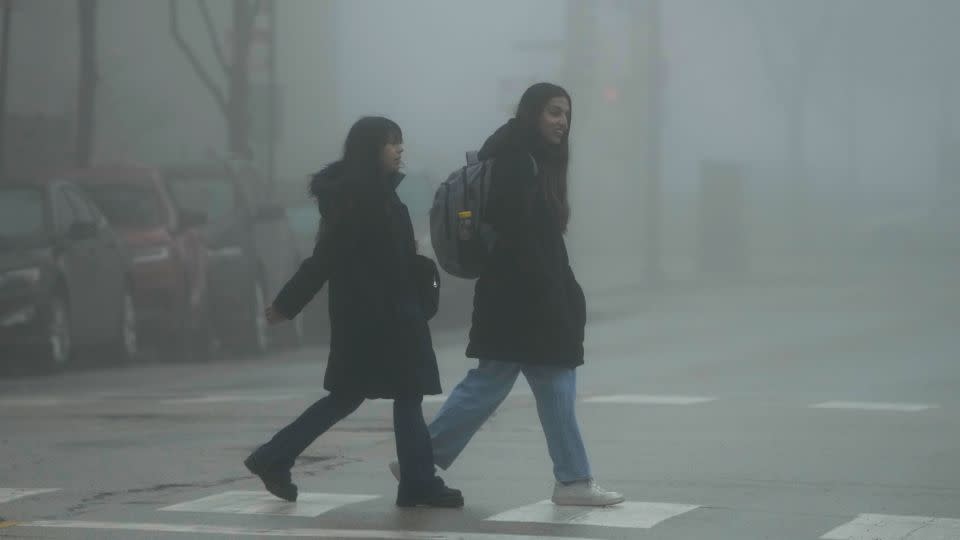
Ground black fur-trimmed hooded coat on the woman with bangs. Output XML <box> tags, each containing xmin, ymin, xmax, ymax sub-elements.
<box><xmin>273</xmin><ymin>166</ymin><xmax>441</xmax><ymax>399</ymax></box>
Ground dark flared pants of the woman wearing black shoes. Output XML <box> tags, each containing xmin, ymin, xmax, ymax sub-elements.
<box><xmin>255</xmin><ymin>394</ymin><xmax>438</xmax><ymax>493</ymax></box>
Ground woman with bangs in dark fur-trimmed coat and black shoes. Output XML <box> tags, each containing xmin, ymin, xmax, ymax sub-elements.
<box><xmin>244</xmin><ymin>117</ymin><xmax>463</xmax><ymax>507</ymax></box>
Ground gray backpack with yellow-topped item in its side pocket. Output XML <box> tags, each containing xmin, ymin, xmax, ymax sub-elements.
<box><xmin>430</xmin><ymin>152</ymin><xmax>537</xmax><ymax>279</ymax></box>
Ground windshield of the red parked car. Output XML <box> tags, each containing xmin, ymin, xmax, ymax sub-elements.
<box><xmin>84</xmin><ymin>184</ymin><xmax>165</xmax><ymax>229</ymax></box>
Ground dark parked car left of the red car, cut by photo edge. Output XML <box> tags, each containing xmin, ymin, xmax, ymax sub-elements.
<box><xmin>0</xmin><ymin>180</ymin><xmax>139</xmax><ymax>370</ymax></box>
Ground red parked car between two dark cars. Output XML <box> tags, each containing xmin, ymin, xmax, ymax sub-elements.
<box><xmin>65</xmin><ymin>164</ymin><xmax>213</xmax><ymax>359</ymax></box>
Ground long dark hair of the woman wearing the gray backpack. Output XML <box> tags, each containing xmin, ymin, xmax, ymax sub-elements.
<box><xmin>515</xmin><ymin>83</ymin><xmax>573</xmax><ymax>232</ymax></box>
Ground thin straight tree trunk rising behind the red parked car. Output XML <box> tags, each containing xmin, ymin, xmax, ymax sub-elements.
<box><xmin>75</xmin><ymin>0</ymin><xmax>98</xmax><ymax>167</ymax></box>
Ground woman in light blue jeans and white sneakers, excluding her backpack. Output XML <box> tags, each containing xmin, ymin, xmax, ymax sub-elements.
<box><xmin>390</xmin><ymin>83</ymin><xmax>624</xmax><ymax>506</ymax></box>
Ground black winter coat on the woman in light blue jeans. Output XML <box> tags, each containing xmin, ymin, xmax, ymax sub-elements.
<box><xmin>467</xmin><ymin>123</ymin><xmax>586</xmax><ymax>368</ymax></box>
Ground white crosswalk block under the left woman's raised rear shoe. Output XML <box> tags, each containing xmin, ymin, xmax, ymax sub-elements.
<box><xmin>160</xmin><ymin>491</ymin><xmax>380</xmax><ymax>517</ymax></box>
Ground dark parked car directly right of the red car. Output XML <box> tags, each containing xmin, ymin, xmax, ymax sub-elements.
<box><xmin>164</xmin><ymin>161</ymin><xmax>303</xmax><ymax>354</ymax></box>
